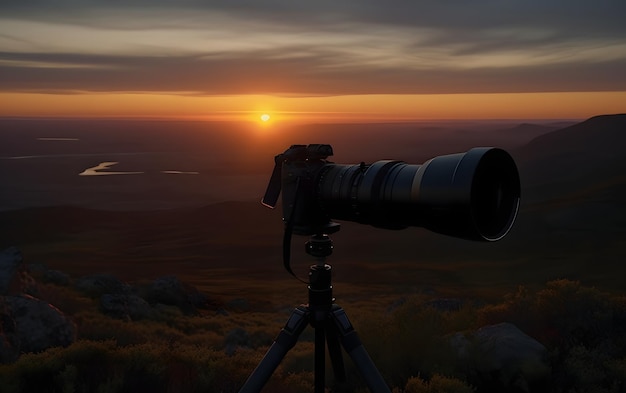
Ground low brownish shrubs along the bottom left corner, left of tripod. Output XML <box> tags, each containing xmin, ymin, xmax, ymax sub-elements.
<box><xmin>0</xmin><ymin>340</ymin><xmax>259</xmax><ymax>393</ymax></box>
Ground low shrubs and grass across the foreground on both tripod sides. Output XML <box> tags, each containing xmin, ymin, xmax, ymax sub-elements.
<box><xmin>0</xmin><ymin>280</ymin><xmax>626</xmax><ymax>393</ymax></box>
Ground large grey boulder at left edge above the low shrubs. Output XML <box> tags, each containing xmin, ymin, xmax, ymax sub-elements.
<box><xmin>4</xmin><ymin>295</ymin><xmax>76</xmax><ymax>353</ymax></box>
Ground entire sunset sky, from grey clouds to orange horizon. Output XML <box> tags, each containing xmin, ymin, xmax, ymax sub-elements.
<box><xmin>0</xmin><ymin>0</ymin><xmax>626</xmax><ymax>121</ymax></box>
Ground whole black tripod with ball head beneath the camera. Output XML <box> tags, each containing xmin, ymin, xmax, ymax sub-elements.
<box><xmin>239</xmin><ymin>234</ymin><xmax>390</xmax><ymax>393</ymax></box>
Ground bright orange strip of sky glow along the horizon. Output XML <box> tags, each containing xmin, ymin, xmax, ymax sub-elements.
<box><xmin>0</xmin><ymin>92</ymin><xmax>626</xmax><ymax>123</ymax></box>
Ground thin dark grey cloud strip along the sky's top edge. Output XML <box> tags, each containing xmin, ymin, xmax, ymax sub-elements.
<box><xmin>0</xmin><ymin>0</ymin><xmax>626</xmax><ymax>38</ymax></box>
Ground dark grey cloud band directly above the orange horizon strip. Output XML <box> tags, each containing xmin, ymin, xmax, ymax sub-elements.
<box><xmin>0</xmin><ymin>51</ymin><xmax>626</xmax><ymax>95</ymax></box>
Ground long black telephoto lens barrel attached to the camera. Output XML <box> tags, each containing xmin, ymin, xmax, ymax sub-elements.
<box><xmin>316</xmin><ymin>147</ymin><xmax>520</xmax><ymax>241</ymax></box>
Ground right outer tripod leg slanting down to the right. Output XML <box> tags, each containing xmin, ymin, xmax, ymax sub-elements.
<box><xmin>331</xmin><ymin>305</ymin><xmax>391</xmax><ymax>393</ymax></box>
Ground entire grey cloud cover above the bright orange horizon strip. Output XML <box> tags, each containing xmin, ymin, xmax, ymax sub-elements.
<box><xmin>0</xmin><ymin>0</ymin><xmax>626</xmax><ymax>95</ymax></box>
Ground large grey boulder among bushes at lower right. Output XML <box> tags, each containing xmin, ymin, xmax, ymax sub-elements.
<box><xmin>449</xmin><ymin>323</ymin><xmax>551</xmax><ymax>392</ymax></box>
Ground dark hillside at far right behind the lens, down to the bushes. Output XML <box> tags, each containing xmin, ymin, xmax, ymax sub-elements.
<box><xmin>500</xmin><ymin>114</ymin><xmax>626</xmax><ymax>291</ymax></box>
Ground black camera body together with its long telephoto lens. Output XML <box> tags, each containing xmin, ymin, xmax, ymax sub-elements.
<box><xmin>263</xmin><ymin>144</ymin><xmax>520</xmax><ymax>241</ymax></box>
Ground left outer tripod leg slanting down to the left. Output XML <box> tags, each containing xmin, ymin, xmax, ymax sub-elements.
<box><xmin>239</xmin><ymin>306</ymin><xmax>310</xmax><ymax>393</ymax></box>
